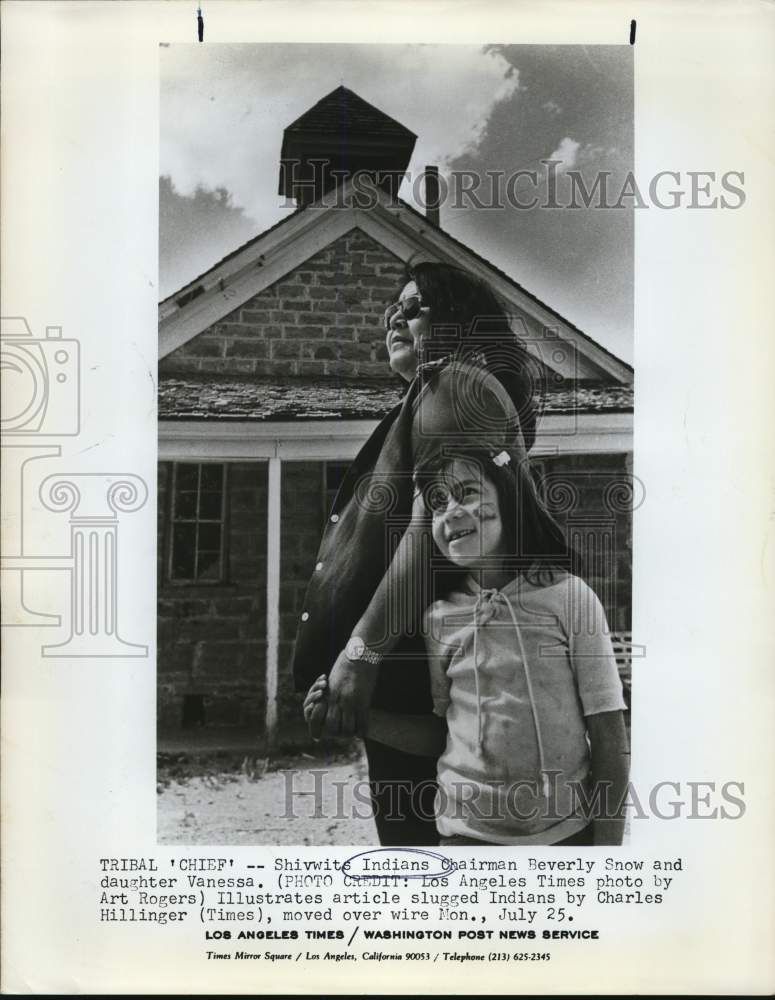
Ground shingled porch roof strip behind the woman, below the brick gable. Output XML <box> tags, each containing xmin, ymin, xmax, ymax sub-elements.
<box><xmin>159</xmin><ymin>375</ymin><xmax>633</xmax><ymax>422</ymax></box>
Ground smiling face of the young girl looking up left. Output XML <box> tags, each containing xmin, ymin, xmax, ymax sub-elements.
<box><xmin>428</xmin><ymin>459</ymin><xmax>506</xmax><ymax>569</ymax></box>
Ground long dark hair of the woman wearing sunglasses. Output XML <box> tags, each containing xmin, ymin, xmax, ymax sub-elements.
<box><xmin>402</xmin><ymin>262</ymin><xmax>543</xmax><ymax>451</ymax></box>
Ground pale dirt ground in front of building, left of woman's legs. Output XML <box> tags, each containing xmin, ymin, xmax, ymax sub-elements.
<box><xmin>157</xmin><ymin>744</ymin><xmax>378</xmax><ymax>846</ymax></box>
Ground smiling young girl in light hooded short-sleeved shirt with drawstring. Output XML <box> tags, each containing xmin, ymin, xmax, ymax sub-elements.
<box><xmin>418</xmin><ymin>451</ymin><xmax>628</xmax><ymax>845</ymax></box>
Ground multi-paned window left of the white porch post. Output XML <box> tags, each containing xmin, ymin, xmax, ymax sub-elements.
<box><xmin>170</xmin><ymin>462</ymin><xmax>226</xmax><ymax>583</ymax></box>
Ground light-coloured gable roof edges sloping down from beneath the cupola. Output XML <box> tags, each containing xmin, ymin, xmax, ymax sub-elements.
<box><xmin>159</xmin><ymin>178</ymin><xmax>633</xmax><ymax>384</ymax></box>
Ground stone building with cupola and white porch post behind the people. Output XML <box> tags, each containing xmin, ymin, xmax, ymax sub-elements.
<box><xmin>158</xmin><ymin>87</ymin><xmax>633</xmax><ymax>739</ymax></box>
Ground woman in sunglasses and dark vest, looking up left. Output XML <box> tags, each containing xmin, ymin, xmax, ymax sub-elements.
<box><xmin>294</xmin><ymin>263</ymin><xmax>559</xmax><ymax>844</ymax></box>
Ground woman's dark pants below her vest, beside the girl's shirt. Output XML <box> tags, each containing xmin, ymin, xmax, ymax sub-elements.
<box><xmin>364</xmin><ymin>740</ymin><xmax>439</xmax><ymax>847</ymax></box>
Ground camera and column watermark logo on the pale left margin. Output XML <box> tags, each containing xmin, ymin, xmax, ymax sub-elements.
<box><xmin>0</xmin><ymin>316</ymin><xmax>148</xmax><ymax>658</ymax></box>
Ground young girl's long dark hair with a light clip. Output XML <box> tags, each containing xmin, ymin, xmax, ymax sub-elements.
<box><xmin>415</xmin><ymin>448</ymin><xmax>580</xmax><ymax>597</ymax></box>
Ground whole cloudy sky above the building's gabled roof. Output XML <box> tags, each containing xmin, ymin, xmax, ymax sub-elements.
<box><xmin>160</xmin><ymin>44</ymin><xmax>633</xmax><ymax>361</ymax></box>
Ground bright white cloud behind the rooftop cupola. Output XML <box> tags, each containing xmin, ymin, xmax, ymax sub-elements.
<box><xmin>160</xmin><ymin>44</ymin><xmax>520</xmax><ymax>227</ymax></box>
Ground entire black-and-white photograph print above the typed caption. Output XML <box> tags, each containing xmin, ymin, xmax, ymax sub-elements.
<box><xmin>157</xmin><ymin>40</ymin><xmax>643</xmax><ymax>845</ymax></box>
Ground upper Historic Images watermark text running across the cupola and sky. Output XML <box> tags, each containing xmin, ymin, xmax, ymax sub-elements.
<box><xmin>282</xmin><ymin>159</ymin><xmax>746</xmax><ymax>211</ymax></box>
